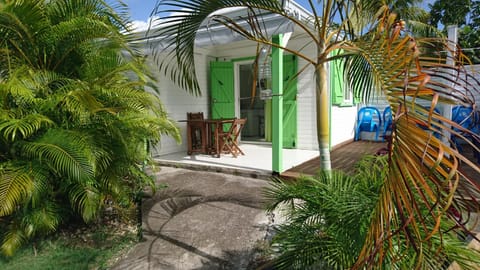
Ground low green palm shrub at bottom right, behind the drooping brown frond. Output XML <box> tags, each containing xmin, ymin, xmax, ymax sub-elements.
<box><xmin>265</xmin><ymin>156</ymin><xmax>480</xmax><ymax>269</ymax></box>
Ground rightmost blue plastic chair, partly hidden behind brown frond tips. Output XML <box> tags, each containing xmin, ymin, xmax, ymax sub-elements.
<box><xmin>452</xmin><ymin>106</ymin><xmax>480</xmax><ymax>160</ymax></box>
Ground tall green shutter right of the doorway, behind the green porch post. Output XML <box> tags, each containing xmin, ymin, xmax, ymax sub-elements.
<box><xmin>283</xmin><ymin>55</ymin><xmax>297</xmax><ymax>148</ymax></box>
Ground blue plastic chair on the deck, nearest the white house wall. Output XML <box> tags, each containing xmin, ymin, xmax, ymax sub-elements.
<box><xmin>354</xmin><ymin>107</ymin><xmax>382</xmax><ymax>141</ymax></box>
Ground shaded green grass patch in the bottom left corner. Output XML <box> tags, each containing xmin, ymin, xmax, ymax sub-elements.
<box><xmin>0</xmin><ymin>223</ymin><xmax>137</xmax><ymax>270</ymax></box>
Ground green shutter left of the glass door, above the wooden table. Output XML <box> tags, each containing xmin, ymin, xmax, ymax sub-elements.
<box><xmin>210</xmin><ymin>62</ymin><xmax>235</xmax><ymax>119</ymax></box>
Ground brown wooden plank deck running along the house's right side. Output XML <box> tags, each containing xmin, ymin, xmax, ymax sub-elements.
<box><xmin>281</xmin><ymin>141</ymin><xmax>387</xmax><ymax>179</ymax></box>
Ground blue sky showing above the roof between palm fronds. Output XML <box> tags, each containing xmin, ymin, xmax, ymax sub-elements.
<box><xmin>123</xmin><ymin>0</ymin><xmax>434</xmax><ymax>30</ymax></box>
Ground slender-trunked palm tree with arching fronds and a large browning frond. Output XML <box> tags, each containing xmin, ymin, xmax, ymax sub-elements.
<box><xmin>152</xmin><ymin>0</ymin><xmax>480</xmax><ymax>268</ymax></box>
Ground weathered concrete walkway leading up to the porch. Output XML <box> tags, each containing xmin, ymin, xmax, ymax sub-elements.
<box><xmin>112</xmin><ymin>167</ymin><xmax>271</xmax><ymax>270</ymax></box>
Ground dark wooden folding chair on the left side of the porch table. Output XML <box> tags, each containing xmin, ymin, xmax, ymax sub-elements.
<box><xmin>187</xmin><ymin>112</ymin><xmax>206</xmax><ymax>155</ymax></box>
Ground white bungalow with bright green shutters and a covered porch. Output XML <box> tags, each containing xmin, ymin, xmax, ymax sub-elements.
<box><xmin>135</xmin><ymin>1</ymin><xmax>357</xmax><ymax>173</ymax></box>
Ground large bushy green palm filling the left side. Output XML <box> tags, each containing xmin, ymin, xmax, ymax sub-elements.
<box><xmin>0</xmin><ymin>0</ymin><xmax>179</xmax><ymax>255</ymax></box>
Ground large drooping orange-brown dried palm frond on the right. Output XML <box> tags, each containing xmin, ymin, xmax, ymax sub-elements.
<box><xmin>349</xmin><ymin>13</ymin><xmax>479</xmax><ymax>267</ymax></box>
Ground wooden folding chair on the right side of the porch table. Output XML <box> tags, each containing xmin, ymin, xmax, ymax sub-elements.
<box><xmin>218</xmin><ymin>118</ymin><xmax>247</xmax><ymax>157</ymax></box>
